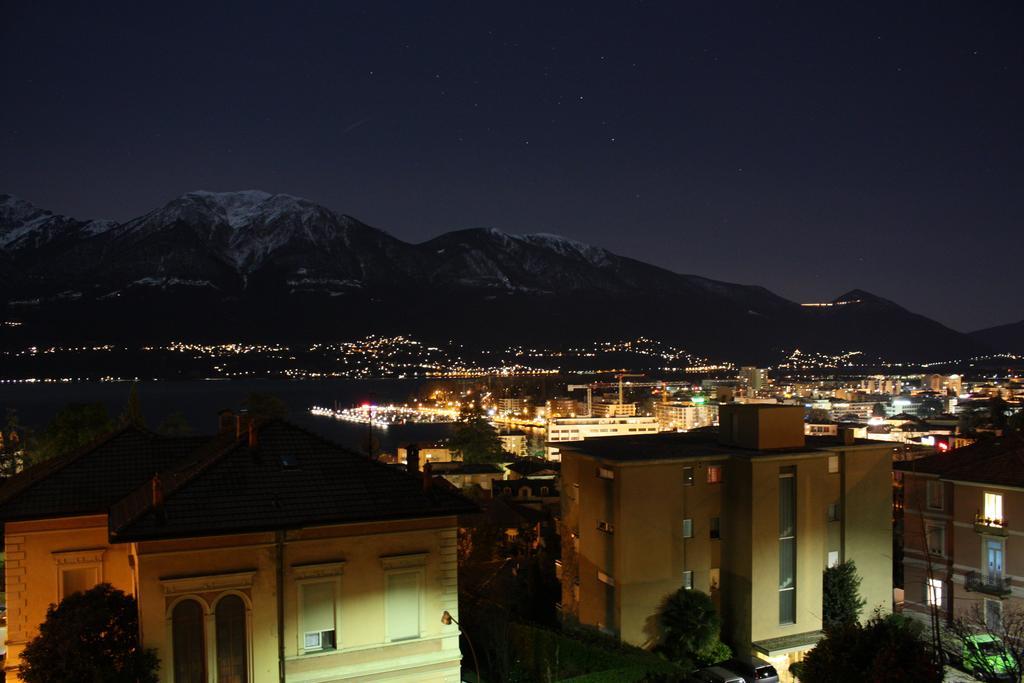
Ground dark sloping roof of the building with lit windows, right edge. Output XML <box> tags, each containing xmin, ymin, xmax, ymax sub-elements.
<box><xmin>895</xmin><ymin>432</ymin><xmax>1024</xmax><ymax>487</ymax></box>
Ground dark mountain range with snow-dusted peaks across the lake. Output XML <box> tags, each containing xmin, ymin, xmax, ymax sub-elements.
<box><xmin>0</xmin><ymin>190</ymin><xmax>987</xmax><ymax>361</ymax></box>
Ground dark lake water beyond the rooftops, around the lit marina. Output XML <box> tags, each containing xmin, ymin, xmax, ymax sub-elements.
<box><xmin>0</xmin><ymin>380</ymin><xmax>460</xmax><ymax>453</ymax></box>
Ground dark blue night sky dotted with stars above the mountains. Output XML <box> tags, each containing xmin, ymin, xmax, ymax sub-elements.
<box><xmin>0</xmin><ymin>1</ymin><xmax>1024</xmax><ymax>331</ymax></box>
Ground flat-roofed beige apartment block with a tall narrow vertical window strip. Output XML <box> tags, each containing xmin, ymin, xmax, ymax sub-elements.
<box><xmin>559</xmin><ymin>404</ymin><xmax>892</xmax><ymax>680</ymax></box>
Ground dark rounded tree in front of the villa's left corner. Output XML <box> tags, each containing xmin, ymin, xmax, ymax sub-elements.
<box><xmin>18</xmin><ymin>584</ymin><xmax>159</xmax><ymax>683</ymax></box>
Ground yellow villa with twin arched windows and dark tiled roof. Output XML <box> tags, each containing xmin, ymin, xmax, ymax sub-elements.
<box><xmin>0</xmin><ymin>416</ymin><xmax>476</xmax><ymax>683</ymax></box>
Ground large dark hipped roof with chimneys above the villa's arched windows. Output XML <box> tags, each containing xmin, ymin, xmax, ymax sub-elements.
<box><xmin>111</xmin><ymin>420</ymin><xmax>477</xmax><ymax>541</ymax></box>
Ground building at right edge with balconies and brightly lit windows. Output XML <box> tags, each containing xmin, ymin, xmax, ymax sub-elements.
<box><xmin>895</xmin><ymin>432</ymin><xmax>1024</xmax><ymax>630</ymax></box>
